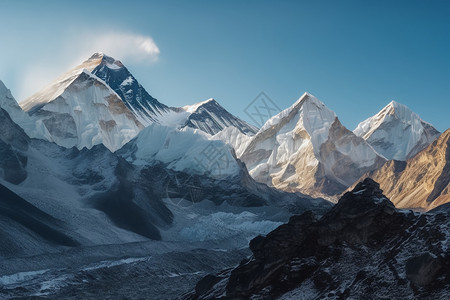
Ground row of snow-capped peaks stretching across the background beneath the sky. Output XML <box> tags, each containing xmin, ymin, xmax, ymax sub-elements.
<box><xmin>0</xmin><ymin>53</ymin><xmax>446</xmax><ymax>207</ymax></box>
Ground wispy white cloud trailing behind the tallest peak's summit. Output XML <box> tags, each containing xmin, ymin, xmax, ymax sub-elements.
<box><xmin>16</xmin><ymin>30</ymin><xmax>160</xmax><ymax>101</ymax></box>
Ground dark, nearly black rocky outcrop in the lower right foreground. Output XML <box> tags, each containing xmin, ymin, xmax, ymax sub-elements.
<box><xmin>185</xmin><ymin>179</ymin><xmax>450</xmax><ymax>299</ymax></box>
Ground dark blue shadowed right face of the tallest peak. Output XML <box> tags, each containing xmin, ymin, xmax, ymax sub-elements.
<box><xmin>88</xmin><ymin>53</ymin><xmax>170</xmax><ymax>126</ymax></box>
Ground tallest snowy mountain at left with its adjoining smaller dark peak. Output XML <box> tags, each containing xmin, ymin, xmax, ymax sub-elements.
<box><xmin>18</xmin><ymin>53</ymin><xmax>257</xmax><ymax>151</ymax></box>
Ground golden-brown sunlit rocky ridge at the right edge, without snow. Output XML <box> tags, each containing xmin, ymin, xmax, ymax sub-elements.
<box><xmin>352</xmin><ymin>129</ymin><xmax>450</xmax><ymax>210</ymax></box>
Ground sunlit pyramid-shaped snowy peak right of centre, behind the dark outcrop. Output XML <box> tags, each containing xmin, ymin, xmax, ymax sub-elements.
<box><xmin>240</xmin><ymin>93</ymin><xmax>385</xmax><ymax>197</ymax></box>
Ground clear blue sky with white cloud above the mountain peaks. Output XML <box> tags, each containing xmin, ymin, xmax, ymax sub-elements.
<box><xmin>0</xmin><ymin>0</ymin><xmax>450</xmax><ymax>131</ymax></box>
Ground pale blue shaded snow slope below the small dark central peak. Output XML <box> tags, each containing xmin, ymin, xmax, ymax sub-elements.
<box><xmin>118</xmin><ymin>123</ymin><xmax>240</xmax><ymax>178</ymax></box>
